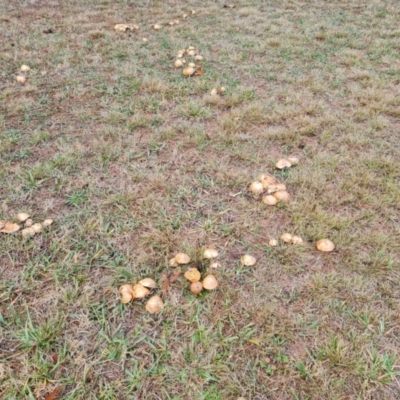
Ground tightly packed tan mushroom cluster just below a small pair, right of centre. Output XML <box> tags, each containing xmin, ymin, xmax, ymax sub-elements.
<box><xmin>249</xmin><ymin>174</ymin><xmax>290</xmax><ymax>206</ymax></box>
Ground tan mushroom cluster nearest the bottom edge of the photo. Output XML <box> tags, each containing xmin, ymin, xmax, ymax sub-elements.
<box><xmin>119</xmin><ymin>278</ymin><xmax>164</xmax><ymax>314</ymax></box>
